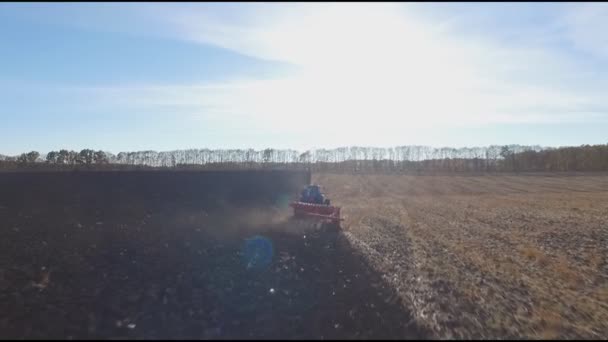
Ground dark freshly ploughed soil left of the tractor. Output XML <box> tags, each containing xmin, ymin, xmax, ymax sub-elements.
<box><xmin>0</xmin><ymin>171</ymin><xmax>427</xmax><ymax>339</ymax></box>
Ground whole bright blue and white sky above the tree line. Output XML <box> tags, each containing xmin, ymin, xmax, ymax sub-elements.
<box><xmin>0</xmin><ymin>2</ymin><xmax>608</xmax><ymax>155</ymax></box>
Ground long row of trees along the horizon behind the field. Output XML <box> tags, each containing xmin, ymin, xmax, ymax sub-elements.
<box><xmin>0</xmin><ymin>144</ymin><xmax>608</xmax><ymax>173</ymax></box>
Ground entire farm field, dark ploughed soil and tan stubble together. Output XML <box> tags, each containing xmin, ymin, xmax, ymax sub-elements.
<box><xmin>0</xmin><ymin>171</ymin><xmax>608</xmax><ymax>339</ymax></box>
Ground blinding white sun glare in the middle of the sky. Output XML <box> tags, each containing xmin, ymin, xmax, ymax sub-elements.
<box><xmin>214</xmin><ymin>5</ymin><xmax>479</xmax><ymax>141</ymax></box>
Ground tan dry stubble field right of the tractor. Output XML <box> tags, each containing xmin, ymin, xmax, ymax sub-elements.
<box><xmin>313</xmin><ymin>174</ymin><xmax>608</xmax><ymax>339</ymax></box>
